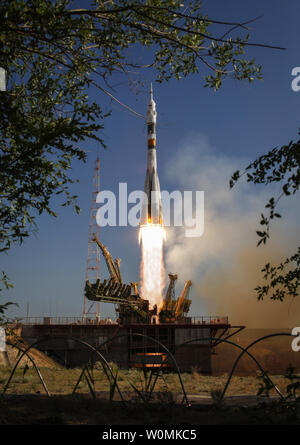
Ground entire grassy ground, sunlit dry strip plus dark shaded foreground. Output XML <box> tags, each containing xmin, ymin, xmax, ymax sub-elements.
<box><xmin>0</xmin><ymin>364</ymin><xmax>300</xmax><ymax>425</ymax></box>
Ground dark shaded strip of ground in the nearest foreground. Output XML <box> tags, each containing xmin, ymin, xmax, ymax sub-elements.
<box><xmin>0</xmin><ymin>395</ymin><xmax>299</xmax><ymax>426</ymax></box>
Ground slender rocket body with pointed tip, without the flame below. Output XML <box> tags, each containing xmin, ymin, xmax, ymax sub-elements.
<box><xmin>140</xmin><ymin>84</ymin><xmax>163</xmax><ymax>226</ymax></box>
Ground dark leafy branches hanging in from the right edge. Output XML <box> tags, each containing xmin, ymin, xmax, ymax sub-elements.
<box><xmin>230</xmin><ymin>134</ymin><xmax>300</xmax><ymax>301</ymax></box>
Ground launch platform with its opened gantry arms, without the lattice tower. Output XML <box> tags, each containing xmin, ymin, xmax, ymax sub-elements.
<box><xmin>18</xmin><ymin>229</ymin><xmax>244</xmax><ymax>374</ymax></box>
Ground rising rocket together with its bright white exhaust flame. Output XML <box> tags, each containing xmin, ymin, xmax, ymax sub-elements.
<box><xmin>139</xmin><ymin>84</ymin><xmax>166</xmax><ymax>308</ymax></box>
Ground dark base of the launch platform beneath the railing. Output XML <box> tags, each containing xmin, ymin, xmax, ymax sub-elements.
<box><xmin>22</xmin><ymin>324</ymin><xmax>236</xmax><ymax>374</ymax></box>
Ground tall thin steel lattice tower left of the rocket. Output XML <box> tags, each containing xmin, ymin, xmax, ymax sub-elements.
<box><xmin>82</xmin><ymin>152</ymin><xmax>100</xmax><ymax>319</ymax></box>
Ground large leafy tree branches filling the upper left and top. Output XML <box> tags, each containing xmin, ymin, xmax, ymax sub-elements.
<box><xmin>0</xmin><ymin>0</ymin><xmax>282</xmax><ymax>251</ymax></box>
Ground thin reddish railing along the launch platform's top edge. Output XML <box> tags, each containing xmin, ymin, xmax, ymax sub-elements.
<box><xmin>15</xmin><ymin>316</ymin><xmax>228</xmax><ymax>325</ymax></box>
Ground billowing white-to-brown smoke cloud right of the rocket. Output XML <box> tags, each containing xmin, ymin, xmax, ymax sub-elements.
<box><xmin>165</xmin><ymin>134</ymin><xmax>300</xmax><ymax>328</ymax></box>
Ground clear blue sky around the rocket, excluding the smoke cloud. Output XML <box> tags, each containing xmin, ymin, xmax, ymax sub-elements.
<box><xmin>1</xmin><ymin>0</ymin><xmax>300</xmax><ymax>326</ymax></box>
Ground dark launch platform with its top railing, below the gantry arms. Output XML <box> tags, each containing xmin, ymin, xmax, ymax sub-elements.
<box><xmin>18</xmin><ymin>317</ymin><xmax>244</xmax><ymax>375</ymax></box>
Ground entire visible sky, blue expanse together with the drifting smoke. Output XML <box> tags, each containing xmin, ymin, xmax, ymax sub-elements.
<box><xmin>1</xmin><ymin>0</ymin><xmax>300</xmax><ymax>327</ymax></box>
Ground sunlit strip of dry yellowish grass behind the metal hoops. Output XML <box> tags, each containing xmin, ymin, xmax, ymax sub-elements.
<box><xmin>0</xmin><ymin>366</ymin><xmax>296</xmax><ymax>396</ymax></box>
